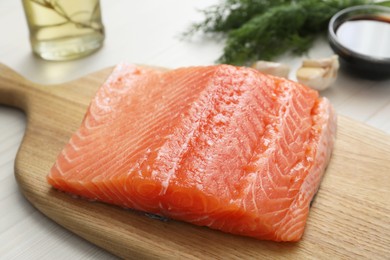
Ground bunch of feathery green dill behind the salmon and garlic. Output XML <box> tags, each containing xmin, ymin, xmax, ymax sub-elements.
<box><xmin>186</xmin><ymin>0</ymin><xmax>388</xmax><ymax>65</ymax></box>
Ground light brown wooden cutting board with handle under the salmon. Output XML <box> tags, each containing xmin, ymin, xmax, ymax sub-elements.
<box><xmin>0</xmin><ymin>64</ymin><xmax>390</xmax><ymax>259</ymax></box>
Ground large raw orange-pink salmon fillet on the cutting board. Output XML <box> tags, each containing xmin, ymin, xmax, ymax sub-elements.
<box><xmin>48</xmin><ymin>64</ymin><xmax>336</xmax><ymax>241</ymax></box>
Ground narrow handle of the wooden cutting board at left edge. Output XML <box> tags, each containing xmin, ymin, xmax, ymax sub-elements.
<box><xmin>0</xmin><ymin>63</ymin><xmax>35</xmax><ymax>111</ymax></box>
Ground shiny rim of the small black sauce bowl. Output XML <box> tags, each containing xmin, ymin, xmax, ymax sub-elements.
<box><xmin>328</xmin><ymin>5</ymin><xmax>390</xmax><ymax>65</ymax></box>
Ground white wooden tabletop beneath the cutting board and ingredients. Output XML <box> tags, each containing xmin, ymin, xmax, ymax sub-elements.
<box><xmin>0</xmin><ymin>0</ymin><xmax>390</xmax><ymax>259</ymax></box>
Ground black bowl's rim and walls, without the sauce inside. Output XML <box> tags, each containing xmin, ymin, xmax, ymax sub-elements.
<box><xmin>328</xmin><ymin>5</ymin><xmax>390</xmax><ymax>79</ymax></box>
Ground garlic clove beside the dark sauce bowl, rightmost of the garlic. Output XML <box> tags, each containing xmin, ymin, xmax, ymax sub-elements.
<box><xmin>296</xmin><ymin>55</ymin><xmax>340</xmax><ymax>90</ymax></box>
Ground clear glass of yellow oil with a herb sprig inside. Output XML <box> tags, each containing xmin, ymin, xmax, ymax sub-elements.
<box><xmin>23</xmin><ymin>0</ymin><xmax>104</xmax><ymax>60</ymax></box>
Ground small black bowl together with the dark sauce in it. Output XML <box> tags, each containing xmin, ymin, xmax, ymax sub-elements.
<box><xmin>328</xmin><ymin>5</ymin><xmax>390</xmax><ymax>79</ymax></box>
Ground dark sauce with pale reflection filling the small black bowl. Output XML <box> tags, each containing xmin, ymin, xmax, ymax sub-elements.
<box><xmin>336</xmin><ymin>16</ymin><xmax>390</xmax><ymax>59</ymax></box>
